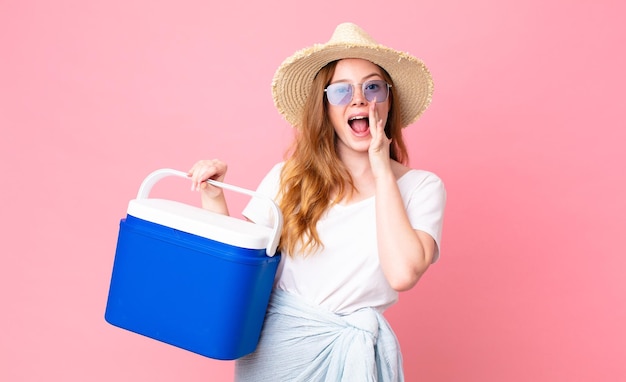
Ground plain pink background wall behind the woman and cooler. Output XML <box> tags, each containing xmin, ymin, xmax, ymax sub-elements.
<box><xmin>0</xmin><ymin>0</ymin><xmax>626</xmax><ymax>381</ymax></box>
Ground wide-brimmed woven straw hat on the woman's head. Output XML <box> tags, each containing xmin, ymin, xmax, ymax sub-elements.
<box><xmin>272</xmin><ymin>23</ymin><xmax>433</xmax><ymax>127</ymax></box>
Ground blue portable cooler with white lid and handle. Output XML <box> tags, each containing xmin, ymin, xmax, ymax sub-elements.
<box><xmin>105</xmin><ymin>169</ymin><xmax>283</xmax><ymax>360</ymax></box>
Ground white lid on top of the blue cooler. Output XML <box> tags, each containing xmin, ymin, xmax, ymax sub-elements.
<box><xmin>127</xmin><ymin>198</ymin><xmax>272</xmax><ymax>249</ymax></box>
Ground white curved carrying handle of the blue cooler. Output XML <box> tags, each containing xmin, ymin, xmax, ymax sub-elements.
<box><xmin>137</xmin><ymin>168</ymin><xmax>283</xmax><ymax>257</ymax></box>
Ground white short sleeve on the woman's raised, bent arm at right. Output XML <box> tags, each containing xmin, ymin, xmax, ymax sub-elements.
<box><xmin>399</xmin><ymin>170</ymin><xmax>447</xmax><ymax>263</ymax></box>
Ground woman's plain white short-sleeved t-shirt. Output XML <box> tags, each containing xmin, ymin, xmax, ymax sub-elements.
<box><xmin>243</xmin><ymin>163</ymin><xmax>446</xmax><ymax>314</ymax></box>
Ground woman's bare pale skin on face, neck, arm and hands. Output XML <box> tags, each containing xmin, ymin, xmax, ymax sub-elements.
<box><xmin>189</xmin><ymin>59</ymin><xmax>436</xmax><ymax>291</ymax></box>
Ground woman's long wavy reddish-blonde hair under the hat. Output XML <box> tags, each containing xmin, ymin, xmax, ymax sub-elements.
<box><xmin>279</xmin><ymin>61</ymin><xmax>408</xmax><ymax>256</ymax></box>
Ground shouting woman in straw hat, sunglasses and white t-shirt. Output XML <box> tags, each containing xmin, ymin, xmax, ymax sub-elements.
<box><xmin>189</xmin><ymin>23</ymin><xmax>446</xmax><ymax>381</ymax></box>
